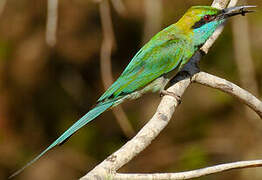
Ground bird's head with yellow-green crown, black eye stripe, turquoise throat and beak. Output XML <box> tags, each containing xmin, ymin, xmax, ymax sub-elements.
<box><xmin>177</xmin><ymin>6</ymin><xmax>256</xmax><ymax>46</ymax></box>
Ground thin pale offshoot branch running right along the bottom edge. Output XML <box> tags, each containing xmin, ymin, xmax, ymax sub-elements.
<box><xmin>114</xmin><ymin>160</ymin><xmax>262</xmax><ymax>180</ymax></box>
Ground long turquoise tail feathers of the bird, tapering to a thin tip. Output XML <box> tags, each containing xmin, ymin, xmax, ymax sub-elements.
<box><xmin>9</xmin><ymin>101</ymin><xmax>114</xmax><ymax>179</ymax></box>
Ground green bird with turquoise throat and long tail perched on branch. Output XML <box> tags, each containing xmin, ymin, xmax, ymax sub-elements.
<box><xmin>9</xmin><ymin>5</ymin><xmax>256</xmax><ymax>178</ymax></box>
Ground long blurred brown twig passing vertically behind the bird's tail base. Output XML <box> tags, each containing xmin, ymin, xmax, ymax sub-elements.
<box><xmin>99</xmin><ymin>0</ymin><xmax>134</xmax><ymax>137</ymax></box>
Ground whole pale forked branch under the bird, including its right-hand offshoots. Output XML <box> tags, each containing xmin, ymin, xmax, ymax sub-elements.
<box><xmin>81</xmin><ymin>0</ymin><xmax>262</xmax><ymax>180</ymax></box>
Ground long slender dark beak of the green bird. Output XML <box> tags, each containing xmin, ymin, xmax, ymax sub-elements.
<box><xmin>220</xmin><ymin>5</ymin><xmax>257</xmax><ymax>19</ymax></box>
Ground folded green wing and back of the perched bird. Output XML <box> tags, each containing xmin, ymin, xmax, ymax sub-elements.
<box><xmin>98</xmin><ymin>32</ymin><xmax>192</xmax><ymax>102</ymax></box>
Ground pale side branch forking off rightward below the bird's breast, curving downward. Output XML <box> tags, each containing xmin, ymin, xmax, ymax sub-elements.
<box><xmin>192</xmin><ymin>72</ymin><xmax>262</xmax><ymax>118</ymax></box>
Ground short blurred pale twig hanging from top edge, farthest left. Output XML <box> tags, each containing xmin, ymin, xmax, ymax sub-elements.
<box><xmin>46</xmin><ymin>0</ymin><xmax>58</xmax><ymax>47</ymax></box>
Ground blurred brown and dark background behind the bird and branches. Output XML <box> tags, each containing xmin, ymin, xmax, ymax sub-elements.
<box><xmin>0</xmin><ymin>0</ymin><xmax>262</xmax><ymax>180</ymax></box>
